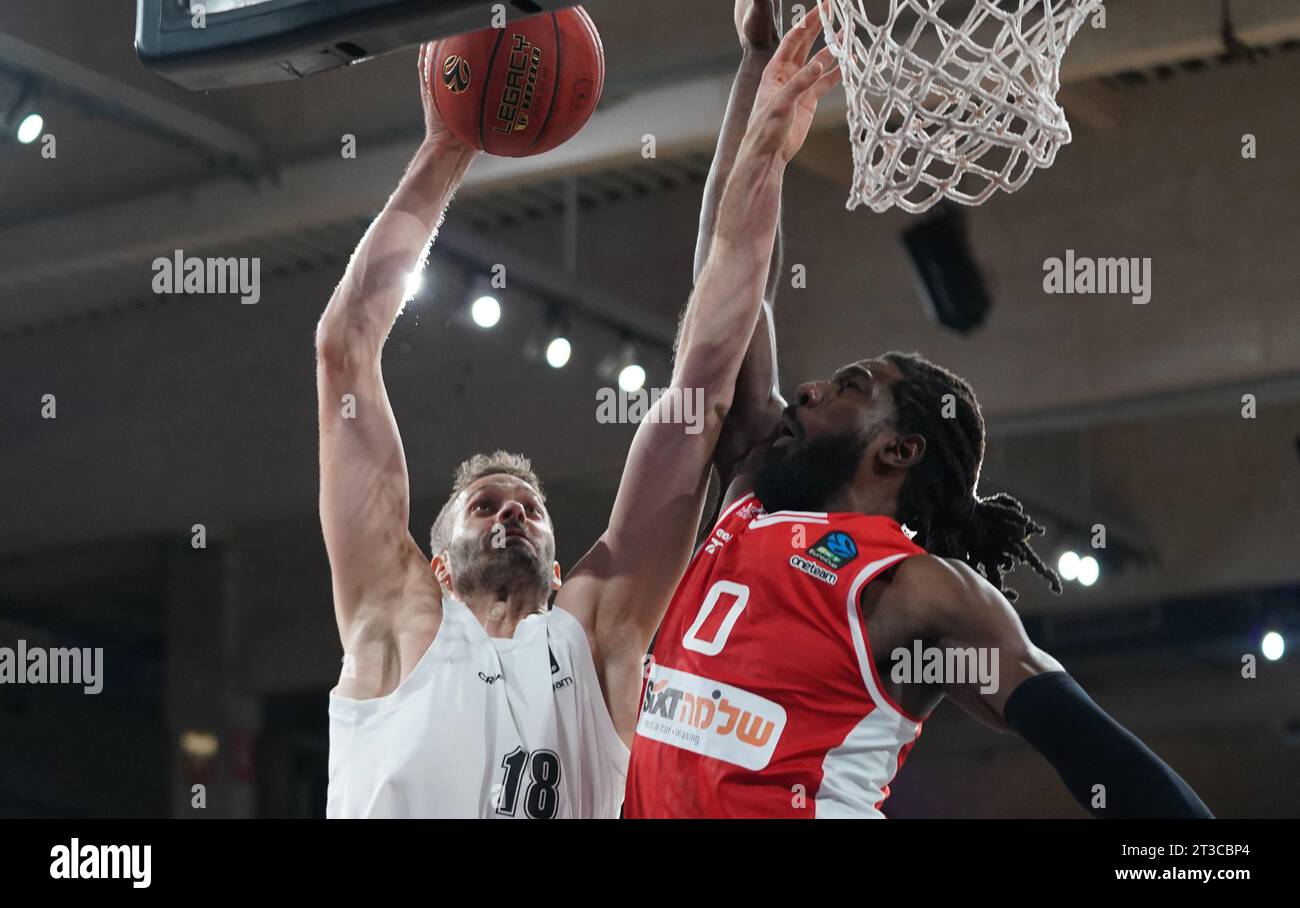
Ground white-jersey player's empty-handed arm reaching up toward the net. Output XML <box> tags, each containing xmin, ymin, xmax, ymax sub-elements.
<box><xmin>556</xmin><ymin>8</ymin><xmax>839</xmax><ymax>738</ymax></box>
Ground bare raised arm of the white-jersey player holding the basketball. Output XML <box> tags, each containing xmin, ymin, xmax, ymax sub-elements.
<box><xmin>316</xmin><ymin>47</ymin><xmax>476</xmax><ymax>676</ymax></box>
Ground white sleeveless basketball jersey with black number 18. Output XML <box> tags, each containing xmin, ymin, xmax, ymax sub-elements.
<box><xmin>325</xmin><ymin>597</ymin><xmax>629</xmax><ymax>818</ymax></box>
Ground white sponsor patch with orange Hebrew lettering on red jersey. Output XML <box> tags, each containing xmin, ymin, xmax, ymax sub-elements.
<box><xmin>637</xmin><ymin>662</ymin><xmax>785</xmax><ymax>770</ymax></box>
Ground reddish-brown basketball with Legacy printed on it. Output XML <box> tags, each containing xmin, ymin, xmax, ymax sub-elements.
<box><xmin>428</xmin><ymin>7</ymin><xmax>605</xmax><ymax>157</ymax></box>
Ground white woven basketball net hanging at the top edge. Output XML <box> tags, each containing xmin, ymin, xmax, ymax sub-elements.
<box><xmin>823</xmin><ymin>0</ymin><xmax>1102</xmax><ymax>213</ymax></box>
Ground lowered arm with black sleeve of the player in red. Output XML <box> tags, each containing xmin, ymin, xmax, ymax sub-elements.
<box><xmin>900</xmin><ymin>557</ymin><xmax>1213</xmax><ymax>820</ymax></box>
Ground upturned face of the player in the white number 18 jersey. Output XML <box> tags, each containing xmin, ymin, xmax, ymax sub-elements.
<box><xmin>447</xmin><ymin>475</ymin><xmax>555</xmax><ymax>596</ymax></box>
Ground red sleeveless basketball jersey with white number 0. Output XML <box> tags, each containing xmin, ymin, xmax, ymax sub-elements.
<box><xmin>623</xmin><ymin>494</ymin><xmax>924</xmax><ymax>818</ymax></box>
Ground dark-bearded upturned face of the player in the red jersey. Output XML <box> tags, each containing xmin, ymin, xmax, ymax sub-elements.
<box><xmin>754</xmin><ymin>359</ymin><xmax>902</xmax><ymax>511</ymax></box>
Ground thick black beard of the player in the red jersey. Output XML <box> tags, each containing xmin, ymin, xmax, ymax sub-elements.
<box><xmin>754</xmin><ymin>432</ymin><xmax>871</xmax><ymax>514</ymax></box>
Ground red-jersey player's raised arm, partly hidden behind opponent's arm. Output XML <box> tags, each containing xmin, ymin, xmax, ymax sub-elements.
<box><xmin>694</xmin><ymin>0</ymin><xmax>785</xmax><ymax>509</ymax></box>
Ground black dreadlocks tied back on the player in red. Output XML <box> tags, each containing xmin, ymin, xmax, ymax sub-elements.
<box><xmin>884</xmin><ymin>351</ymin><xmax>1061</xmax><ymax>602</ymax></box>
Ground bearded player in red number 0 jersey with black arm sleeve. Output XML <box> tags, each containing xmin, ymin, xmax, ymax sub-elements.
<box><xmin>624</xmin><ymin>0</ymin><xmax>1210</xmax><ymax>818</ymax></box>
